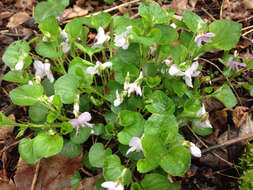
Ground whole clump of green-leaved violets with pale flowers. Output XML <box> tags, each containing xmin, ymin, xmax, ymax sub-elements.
<box><xmin>0</xmin><ymin>0</ymin><xmax>252</xmax><ymax>190</ymax></box>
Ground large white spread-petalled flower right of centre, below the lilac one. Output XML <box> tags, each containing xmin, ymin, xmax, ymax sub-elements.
<box><xmin>169</xmin><ymin>61</ymin><xmax>200</xmax><ymax>88</ymax></box>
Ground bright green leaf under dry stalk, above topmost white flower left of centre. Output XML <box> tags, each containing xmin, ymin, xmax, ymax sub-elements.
<box><xmin>81</xmin><ymin>12</ymin><xmax>112</xmax><ymax>29</ymax></box>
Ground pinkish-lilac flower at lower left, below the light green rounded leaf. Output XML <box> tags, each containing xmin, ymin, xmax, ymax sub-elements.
<box><xmin>69</xmin><ymin>112</ymin><xmax>92</xmax><ymax>136</ymax></box>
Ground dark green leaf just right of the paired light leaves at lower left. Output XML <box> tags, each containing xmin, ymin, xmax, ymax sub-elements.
<box><xmin>61</xmin><ymin>139</ymin><xmax>82</xmax><ymax>158</ymax></box>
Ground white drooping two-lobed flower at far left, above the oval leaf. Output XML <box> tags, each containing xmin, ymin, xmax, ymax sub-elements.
<box><xmin>33</xmin><ymin>60</ymin><xmax>54</xmax><ymax>83</ymax></box>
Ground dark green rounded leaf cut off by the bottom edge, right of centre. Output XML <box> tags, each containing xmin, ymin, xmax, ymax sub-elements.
<box><xmin>141</xmin><ymin>173</ymin><xmax>177</xmax><ymax>190</ymax></box>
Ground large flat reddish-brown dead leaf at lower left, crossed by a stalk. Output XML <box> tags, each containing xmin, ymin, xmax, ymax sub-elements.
<box><xmin>14</xmin><ymin>155</ymin><xmax>82</xmax><ymax>190</ymax></box>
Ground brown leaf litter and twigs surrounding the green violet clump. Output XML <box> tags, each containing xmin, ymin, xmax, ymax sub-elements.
<box><xmin>0</xmin><ymin>0</ymin><xmax>253</xmax><ymax>190</ymax></box>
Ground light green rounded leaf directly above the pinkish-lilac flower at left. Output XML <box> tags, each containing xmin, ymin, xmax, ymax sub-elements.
<box><xmin>54</xmin><ymin>74</ymin><xmax>78</xmax><ymax>104</ymax></box>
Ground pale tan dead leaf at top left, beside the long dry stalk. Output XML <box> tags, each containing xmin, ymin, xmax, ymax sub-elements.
<box><xmin>57</xmin><ymin>5</ymin><xmax>89</xmax><ymax>22</ymax></box>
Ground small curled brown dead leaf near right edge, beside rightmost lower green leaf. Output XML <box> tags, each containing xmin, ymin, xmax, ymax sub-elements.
<box><xmin>232</xmin><ymin>106</ymin><xmax>249</xmax><ymax>127</ymax></box>
